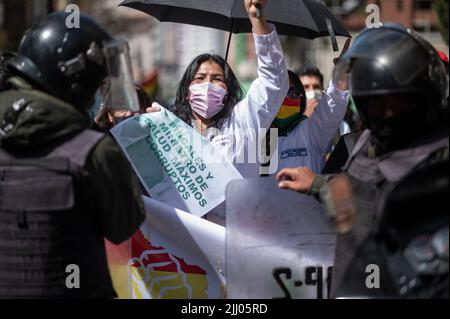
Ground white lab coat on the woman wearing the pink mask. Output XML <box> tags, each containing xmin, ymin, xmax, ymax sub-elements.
<box><xmin>206</xmin><ymin>25</ymin><xmax>289</xmax><ymax>178</ymax></box>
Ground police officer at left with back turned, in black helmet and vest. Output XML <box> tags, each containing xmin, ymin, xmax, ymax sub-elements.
<box><xmin>0</xmin><ymin>12</ymin><xmax>144</xmax><ymax>298</ymax></box>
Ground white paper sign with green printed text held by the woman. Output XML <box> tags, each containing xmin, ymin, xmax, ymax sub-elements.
<box><xmin>111</xmin><ymin>107</ymin><xmax>242</xmax><ymax>216</ymax></box>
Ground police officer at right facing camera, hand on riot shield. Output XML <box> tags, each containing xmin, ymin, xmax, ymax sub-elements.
<box><xmin>277</xmin><ymin>24</ymin><xmax>448</xmax><ymax>298</ymax></box>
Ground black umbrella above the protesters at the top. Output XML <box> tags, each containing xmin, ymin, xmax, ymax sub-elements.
<box><xmin>120</xmin><ymin>0</ymin><xmax>350</xmax><ymax>56</ymax></box>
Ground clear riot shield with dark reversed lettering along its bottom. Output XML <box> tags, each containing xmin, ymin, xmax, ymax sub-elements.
<box><xmin>226</xmin><ymin>178</ymin><xmax>336</xmax><ymax>299</ymax></box>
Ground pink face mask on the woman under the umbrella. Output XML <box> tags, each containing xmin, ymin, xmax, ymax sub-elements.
<box><xmin>189</xmin><ymin>82</ymin><xmax>227</xmax><ymax>119</ymax></box>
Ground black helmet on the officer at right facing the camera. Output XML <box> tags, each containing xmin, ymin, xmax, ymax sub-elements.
<box><xmin>334</xmin><ymin>24</ymin><xmax>448</xmax><ymax>149</ymax></box>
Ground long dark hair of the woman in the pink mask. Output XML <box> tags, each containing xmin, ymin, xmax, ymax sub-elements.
<box><xmin>172</xmin><ymin>54</ymin><xmax>244</xmax><ymax>129</ymax></box>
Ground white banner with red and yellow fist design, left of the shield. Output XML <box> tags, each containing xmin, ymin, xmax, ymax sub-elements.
<box><xmin>130</xmin><ymin>197</ymin><xmax>225</xmax><ymax>299</ymax></box>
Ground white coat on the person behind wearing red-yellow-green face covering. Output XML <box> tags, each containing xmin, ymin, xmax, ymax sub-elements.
<box><xmin>278</xmin><ymin>81</ymin><xmax>349</xmax><ymax>174</ymax></box>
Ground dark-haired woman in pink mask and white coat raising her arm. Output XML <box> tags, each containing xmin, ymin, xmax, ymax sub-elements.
<box><xmin>172</xmin><ymin>0</ymin><xmax>289</xmax><ymax>178</ymax></box>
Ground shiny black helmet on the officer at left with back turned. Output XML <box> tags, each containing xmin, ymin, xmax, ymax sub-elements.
<box><xmin>9</xmin><ymin>12</ymin><xmax>113</xmax><ymax>109</ymax></box>
